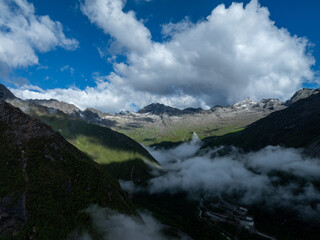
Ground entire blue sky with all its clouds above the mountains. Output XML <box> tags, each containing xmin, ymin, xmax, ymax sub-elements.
<box><xmin>0</xmin><ymin>0</ymin><xmax>320</xmax><ymax>112</ymax></box>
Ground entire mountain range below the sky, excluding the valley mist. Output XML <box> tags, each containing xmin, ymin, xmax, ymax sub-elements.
<box><xmin>0</xmin><ymin>84</ymin><xmax>320</xmax><ymax>239</ymax></box>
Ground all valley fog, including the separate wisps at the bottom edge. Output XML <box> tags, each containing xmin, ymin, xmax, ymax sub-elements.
<box><xmin>69</xmin><ymin>134</ymin><xmax>320</xmax><ymax>240</ymax></box>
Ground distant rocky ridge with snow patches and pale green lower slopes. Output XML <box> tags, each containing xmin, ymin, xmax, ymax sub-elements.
<box><xmin>1</xmin><ymin>83</ymin><xmax>319</xmax><ymax>145</ymax></box>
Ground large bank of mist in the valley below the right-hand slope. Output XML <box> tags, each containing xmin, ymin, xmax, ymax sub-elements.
<box><xmin>144</xmin><ymin>135</ymin><xmax>320</xmax><ymax>220</ymax></box>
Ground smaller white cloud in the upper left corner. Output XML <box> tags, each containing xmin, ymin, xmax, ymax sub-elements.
<box><xmin>0</xmin><ymin>0</ymin><xmax>78</xmax><ymax>68</ymax></box>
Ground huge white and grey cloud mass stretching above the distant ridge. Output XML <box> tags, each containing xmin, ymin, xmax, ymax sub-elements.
<box><xmin>14</xmin><ymin>0</ymin><xmax>315</xmax><ymax>112</ymax></box>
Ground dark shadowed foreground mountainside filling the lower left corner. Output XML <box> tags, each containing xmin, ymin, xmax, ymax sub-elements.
<box><xmin>0</xmin><ymin>100</ymin><xmax>136</xmax><ymax>240</ymax></box>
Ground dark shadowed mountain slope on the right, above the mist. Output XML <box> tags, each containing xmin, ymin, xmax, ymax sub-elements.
<box><xmin>206</xmin><ymin>89</ymin><xmax>320</xmax><ymax>155</ymax></box>
